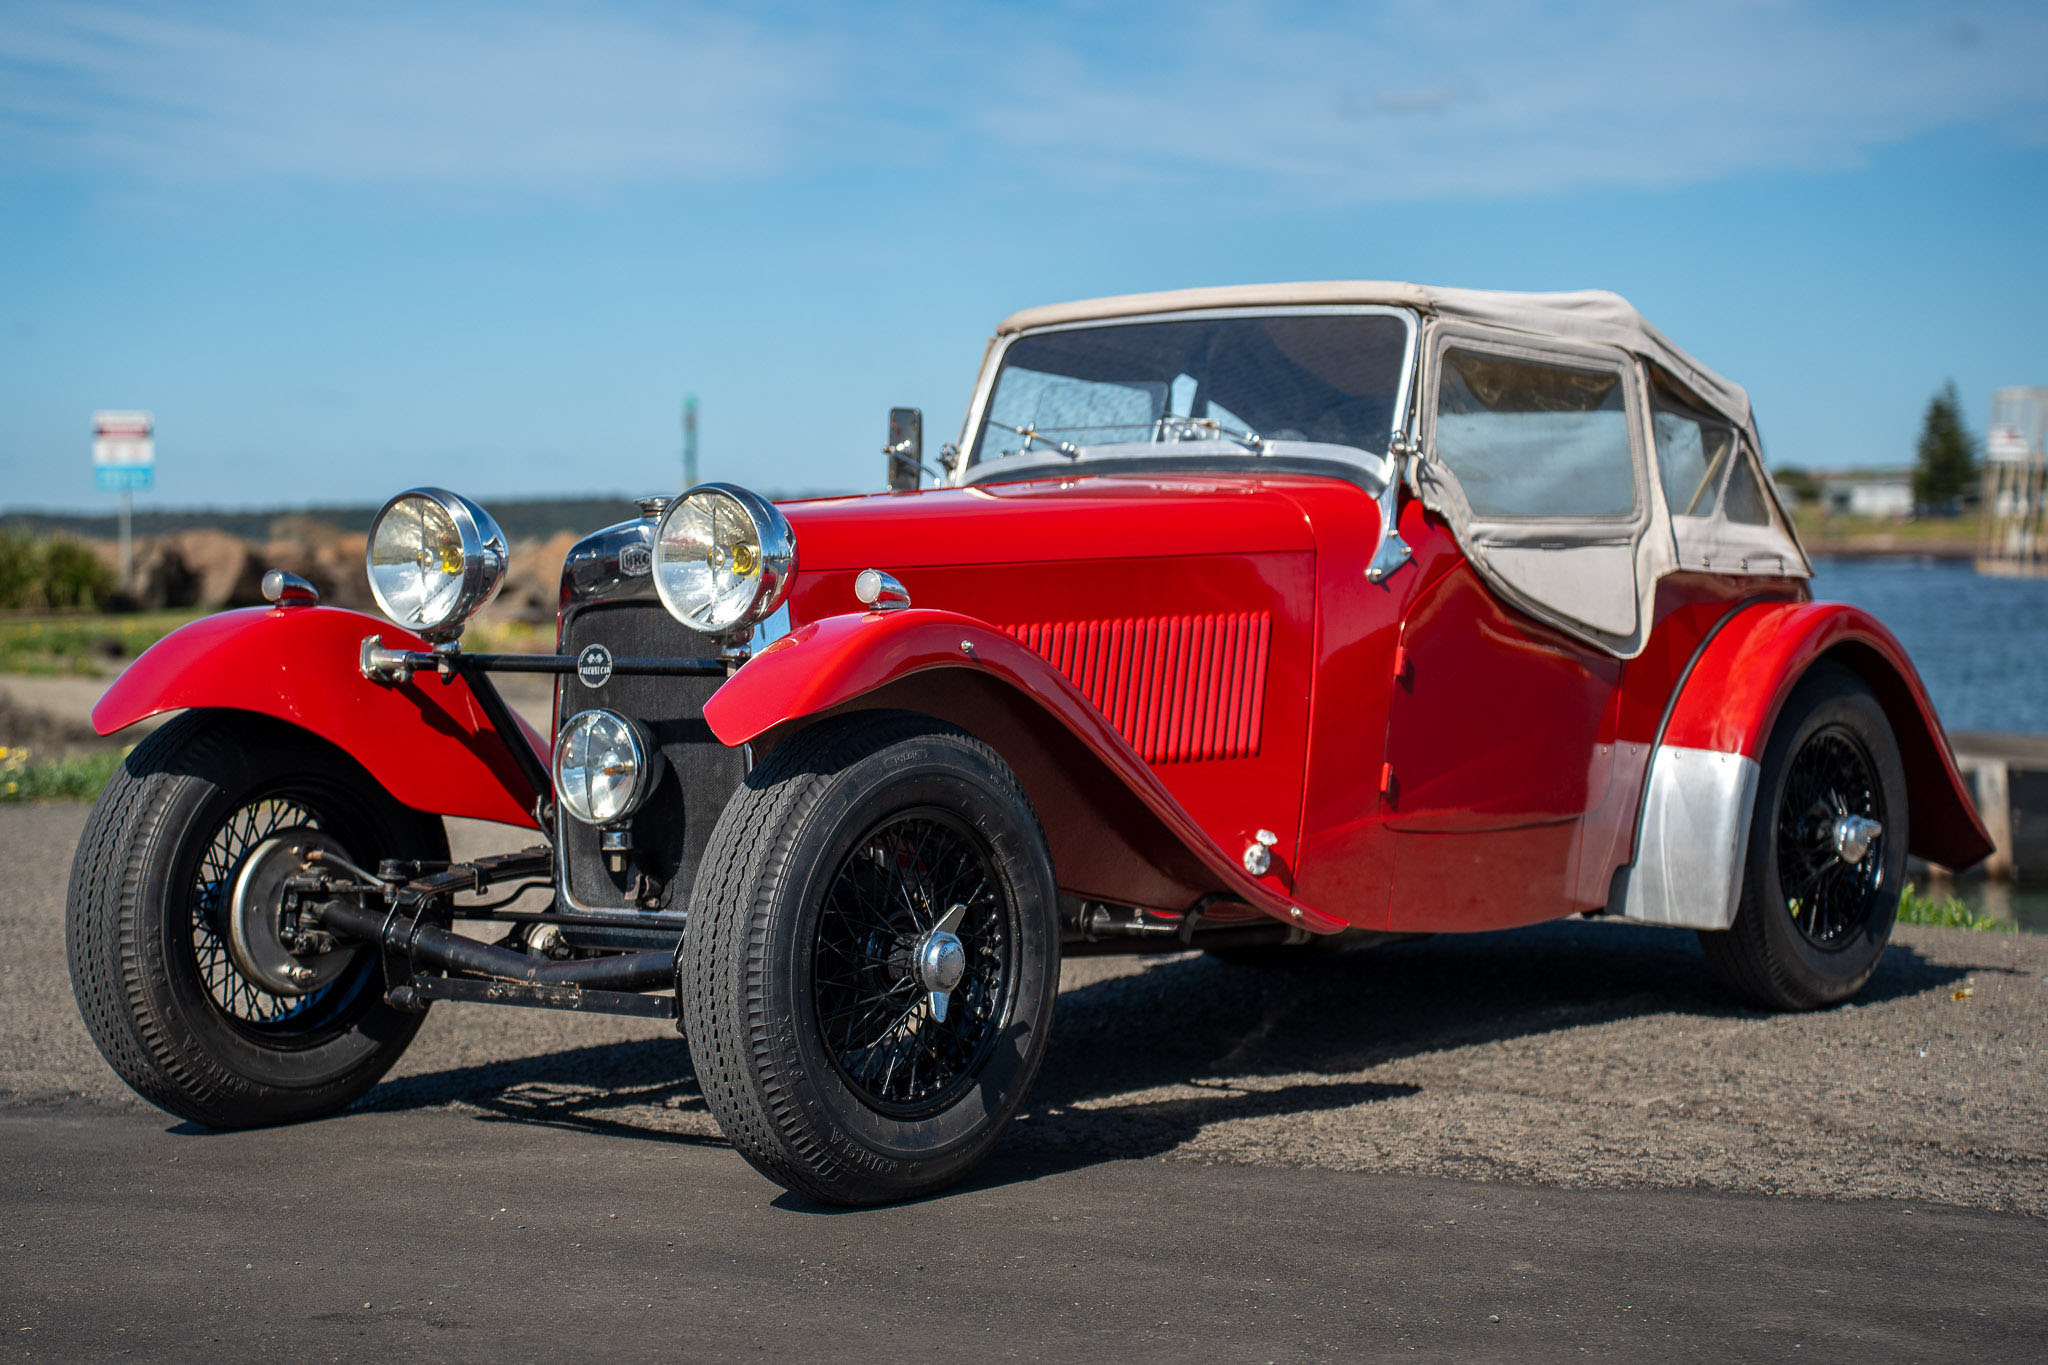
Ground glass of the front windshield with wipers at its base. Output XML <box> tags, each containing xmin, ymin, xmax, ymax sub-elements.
<box><xmin>967</xmin><ymin>313</ymin><xmax>1409</xmax><ymax>474</ymax></box>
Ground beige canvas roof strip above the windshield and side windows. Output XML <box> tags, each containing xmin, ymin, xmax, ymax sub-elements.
<box><xmin>995</xmin><ymin>280</ymin><xmax>1761</xmax><ymax>448</ymax></box>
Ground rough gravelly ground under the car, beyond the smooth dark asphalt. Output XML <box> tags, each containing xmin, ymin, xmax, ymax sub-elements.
<box><xmin>0</xmin><ymin>806</ymin><xmax>2048</xmax><ymax>1216</ymax></box>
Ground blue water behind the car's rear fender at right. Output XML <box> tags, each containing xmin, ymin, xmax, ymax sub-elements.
<box><xmin>1812</xmin><ymin>559</ymin><xmax>2048</xmax><ymax>735</ymax></box>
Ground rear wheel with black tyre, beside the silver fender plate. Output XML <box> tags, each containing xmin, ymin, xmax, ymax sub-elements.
<box><xmin>1700</xmin><ymin>661</ymin><xmax>1907</xmax><ymax>1009</ymax></box>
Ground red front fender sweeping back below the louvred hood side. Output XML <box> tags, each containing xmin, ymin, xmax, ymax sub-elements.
<box><xmin>705</xmin><ymin>608</ymin><xmax>1348</xmax><ymax>933</ymax></box>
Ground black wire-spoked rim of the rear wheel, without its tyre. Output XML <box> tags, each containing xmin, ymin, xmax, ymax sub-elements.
<box><xmin>1776</xmin><ymin>724</ymin><xmax>1886</xmax><ymax>950</ymax></box>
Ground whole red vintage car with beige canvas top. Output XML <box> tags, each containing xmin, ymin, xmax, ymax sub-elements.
<box><xmin>70</xmin><ymin>282</ymin><xmax>1989</xmax><ymax>1203</ymax></box>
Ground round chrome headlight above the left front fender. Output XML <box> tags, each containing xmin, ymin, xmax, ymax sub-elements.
<box><xmin>362</xmin><ymin>489</ymin><xmax>506</xmax><ymax>639</ymax></box>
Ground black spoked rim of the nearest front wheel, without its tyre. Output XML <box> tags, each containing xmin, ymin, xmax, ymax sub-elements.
<box><xmin>811</xmin><ymin>808</ymin><xmax>1016</xmax><ymax>1117</ymax></box>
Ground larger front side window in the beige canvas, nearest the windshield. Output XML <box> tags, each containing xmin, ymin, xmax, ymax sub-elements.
<box><xmin>1436</xmin><ymin>348</ymin><xmax>1636</xmax><ymax>516</ymax></box>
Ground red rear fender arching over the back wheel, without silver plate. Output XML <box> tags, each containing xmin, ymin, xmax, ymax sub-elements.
<box><xmin>1661</xmin><ymin>602</ymin><xmax>1991</xmax><ymax>870</ymax></box>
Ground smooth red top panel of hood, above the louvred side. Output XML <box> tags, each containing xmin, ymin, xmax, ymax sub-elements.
<box><xmin>782</xmin><ymin>475</ymin><xmax>1315</xmax><ymax>573</ymax></box>
